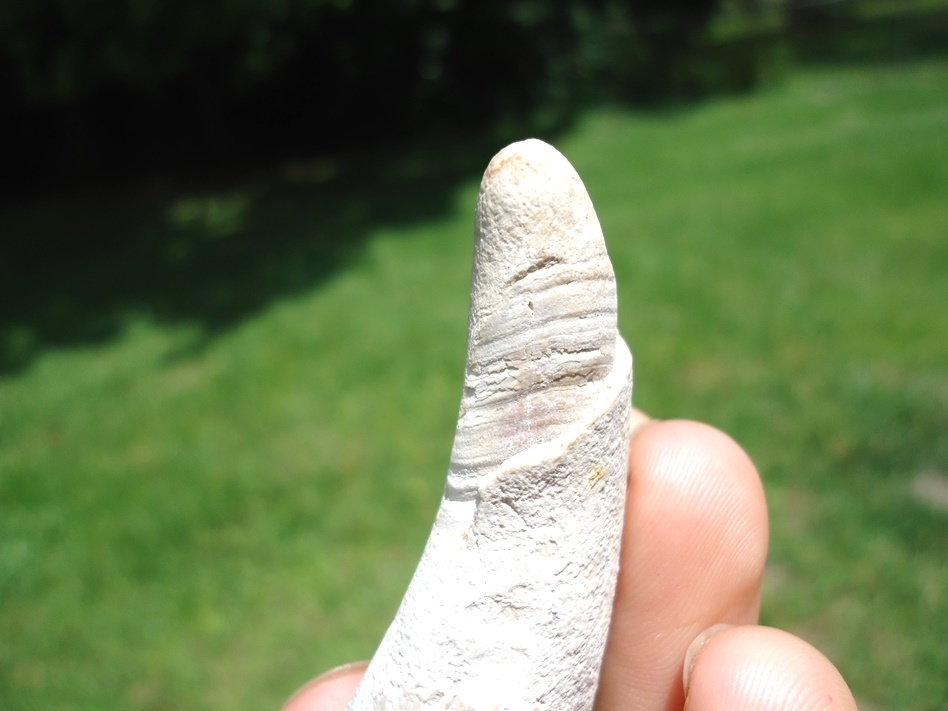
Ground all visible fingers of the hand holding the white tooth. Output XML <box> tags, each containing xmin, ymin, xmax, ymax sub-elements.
<box><xmin>283</xmin><ymin>413</ymin><xmax>856</xmax><ymax>711</ymax></box>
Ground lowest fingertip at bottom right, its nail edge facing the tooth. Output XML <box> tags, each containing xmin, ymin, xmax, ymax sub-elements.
<box><xmin>685</xmin><ymin>626</ymin><xmax>856</xmax><ymax>711</ymax></box>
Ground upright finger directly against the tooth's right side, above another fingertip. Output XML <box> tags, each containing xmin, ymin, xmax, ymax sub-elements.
<box><xmin>596</xmin><ymin>421</ymin><xmax>768</xmax><ymax>711</ymax></box>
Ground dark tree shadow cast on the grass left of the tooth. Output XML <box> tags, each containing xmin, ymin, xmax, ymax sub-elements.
<box><xmin>0</xmin><ymin>135</ymin><xmax>532</xmax><ymax>376</ymax></box>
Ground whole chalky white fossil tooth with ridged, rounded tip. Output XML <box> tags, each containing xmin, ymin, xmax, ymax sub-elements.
<box><xmin>348</xmin><ymin>140</ymin><xmax>632</xmax><ymax>711</ymax></box>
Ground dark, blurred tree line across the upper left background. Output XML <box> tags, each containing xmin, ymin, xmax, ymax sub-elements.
<box><xmin>0</xmin><ymin>0</ymin><xmax>756</xmax><ymax>191</ymax></box>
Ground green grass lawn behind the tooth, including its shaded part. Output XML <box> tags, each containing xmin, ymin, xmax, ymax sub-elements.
<box><xmin>0</xmin><ymin>62</ymin><xmax>948</xmax><ymax>711</ymax></box>
